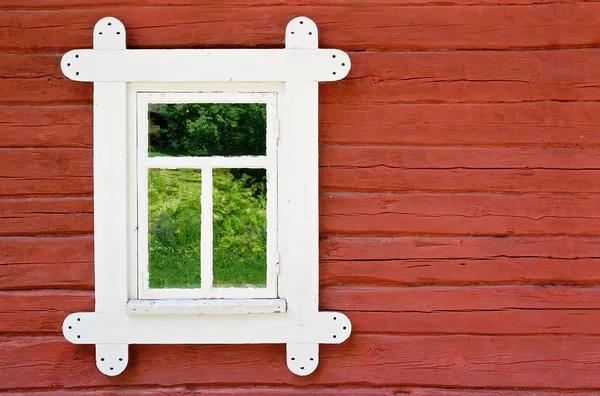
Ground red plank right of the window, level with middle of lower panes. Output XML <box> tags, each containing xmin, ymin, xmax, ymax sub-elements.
<box><xmin>320</xmin><ymin>192</ymin><xmax>600</xmax><ymax>235</ymax></box>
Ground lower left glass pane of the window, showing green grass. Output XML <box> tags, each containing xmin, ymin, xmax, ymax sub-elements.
<box><xmin>148</xmin><ymin>169</ymin><xmax>202</xmax><ymax>288</ymax></box>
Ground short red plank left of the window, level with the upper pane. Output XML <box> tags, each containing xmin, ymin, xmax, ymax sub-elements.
<box><xmin>0</xmin><ymin>106</ymin><xmax>92</xmax><ymax>148</ymax></box>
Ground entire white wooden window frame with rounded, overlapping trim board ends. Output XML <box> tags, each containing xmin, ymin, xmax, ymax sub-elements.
<box><xmin>61</xmin><ymin>17</ymin><xmax>351</xmax><ymax>376</ymax></box>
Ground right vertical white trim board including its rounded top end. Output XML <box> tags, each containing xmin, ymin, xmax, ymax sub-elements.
<box><xmin>278</xmin><ymin>17</ymin><xmax>322</xmax><ymax>314</ymax></box>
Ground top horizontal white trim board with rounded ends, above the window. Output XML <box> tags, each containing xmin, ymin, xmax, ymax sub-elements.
<box><xmin>61</xmin><ymin>48</ymin><xmax>350</xmax><ymax>82</ymax></box>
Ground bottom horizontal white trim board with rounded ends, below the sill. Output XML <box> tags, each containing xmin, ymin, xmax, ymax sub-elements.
<box><xmin>63</xmin><ymin>312</ymin><xmax>351</xmax><ymax>344</ymax></box>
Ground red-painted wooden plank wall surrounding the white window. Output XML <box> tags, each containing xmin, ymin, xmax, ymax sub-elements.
<box><xmin>0</xmin><ymin>0</ymin><xmax>600</xmax><ymax>396</ymax></box>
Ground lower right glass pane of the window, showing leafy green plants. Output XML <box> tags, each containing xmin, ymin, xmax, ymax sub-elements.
<box><xmin>213</xmin><ymin>169</ymin><xmax>267</xmax><ymax>287</ymax></box>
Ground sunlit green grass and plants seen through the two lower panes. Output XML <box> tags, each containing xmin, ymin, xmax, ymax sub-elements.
<box><xmin>148</xmin><ymin>167</ymin><xmax>266</xmax><ymax>288</ymax></box>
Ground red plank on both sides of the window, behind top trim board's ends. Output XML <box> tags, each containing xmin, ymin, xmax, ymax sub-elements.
<box><xmin>0</xmin><ymin>50</ymin><xmax>600</xmax><ymax>105</ymax></box>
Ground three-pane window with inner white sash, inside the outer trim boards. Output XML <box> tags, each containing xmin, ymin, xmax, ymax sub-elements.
<box><xmin>136</xmin><ymin>92</ymin><xmax>285</xmax><ymax>304</ymax></box>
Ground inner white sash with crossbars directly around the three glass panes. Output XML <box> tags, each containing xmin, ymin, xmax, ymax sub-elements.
<box><xmin>136</xmin><ymin>90</ymin><xmax>283</xmax><ymax>300</ymax></box>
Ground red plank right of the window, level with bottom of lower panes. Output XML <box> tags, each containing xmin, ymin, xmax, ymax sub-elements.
<box><xmin>320</xmin><ymin>256</ymin><xmax>600</xmax><ymax>286</ymax></box>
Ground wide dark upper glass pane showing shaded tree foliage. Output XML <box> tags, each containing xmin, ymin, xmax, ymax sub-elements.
<box><xmin>148</xmin><ymin>103</ymin><xmax>267</xmax><ymax>157</ymax></box>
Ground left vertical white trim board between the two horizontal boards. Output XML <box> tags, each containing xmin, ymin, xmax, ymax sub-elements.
<box><xmin>94</xmin><ymin>83</ymin><xmax>128</xmax><ymax>312</ymax></box>
